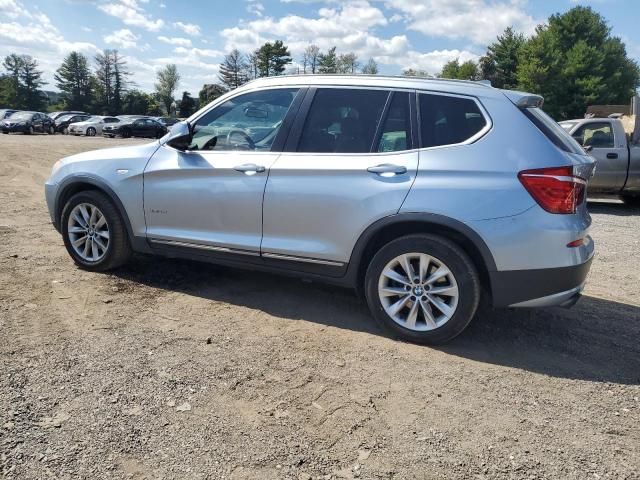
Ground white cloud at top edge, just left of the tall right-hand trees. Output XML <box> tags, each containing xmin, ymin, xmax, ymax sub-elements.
<box><xmin>386</xmin><ymin>0</ymin><xmax>539</xmax><ymax>45</ymax></box>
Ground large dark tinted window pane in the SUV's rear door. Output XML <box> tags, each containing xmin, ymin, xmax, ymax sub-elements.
<box><xmin>298</xmin><ymin>88</ymin><xmax>389</xmax><ymax>153</ymax></box>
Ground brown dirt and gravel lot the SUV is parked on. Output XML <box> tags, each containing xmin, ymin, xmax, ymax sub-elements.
<box><xmin>0</xmin><ymin>135</ymin><xmax>640</xmax><ymax>479</ymax></box>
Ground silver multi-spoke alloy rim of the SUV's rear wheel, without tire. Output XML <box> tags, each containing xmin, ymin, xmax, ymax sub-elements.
<box><xmin>378</xmin><ymin>253</ymin><xmax>460</xmax><ymax>332</ymax></box>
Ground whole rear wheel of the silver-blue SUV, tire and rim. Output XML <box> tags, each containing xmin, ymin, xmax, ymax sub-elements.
<box><xmin>365</xmin><ymin>234</ymin><xmax>480</xmax><ymax>345</ymax></box>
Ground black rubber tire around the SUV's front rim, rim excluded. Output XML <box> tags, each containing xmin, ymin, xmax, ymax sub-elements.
<box><xmin>60</xmin><ymin>190</ymin><xmax>132</xmax><ymax>272</ymax></box>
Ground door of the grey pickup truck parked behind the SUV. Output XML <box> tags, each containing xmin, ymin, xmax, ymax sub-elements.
<box><xmin>571</xmin><ymin>121</ymin><xmax>629</xmax><ymax>192</ymax></box>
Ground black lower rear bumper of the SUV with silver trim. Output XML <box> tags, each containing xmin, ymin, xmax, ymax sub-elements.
<box><xmin>489</xmin><ymin>257</ymin><xmax>593</xmax><ymax>307</ymax></box>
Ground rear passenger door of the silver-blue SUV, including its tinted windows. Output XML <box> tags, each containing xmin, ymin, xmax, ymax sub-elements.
<box><xmin>262</xmin><ymin>87</ymin><xmax>418</xmax><ymax>268</ymax></box>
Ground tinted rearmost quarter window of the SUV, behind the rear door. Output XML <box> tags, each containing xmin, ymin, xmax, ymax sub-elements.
<box><xmin>419</xmin><ymin>93</ymin><xmax>487</xmax><ymax>148</ymax></box>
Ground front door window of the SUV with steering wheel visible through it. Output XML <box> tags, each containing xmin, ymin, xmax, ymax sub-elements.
<box><xmin>189</xmin><ymin>88</ymin><xmax>298</xmax><ymax>151</ymax></box>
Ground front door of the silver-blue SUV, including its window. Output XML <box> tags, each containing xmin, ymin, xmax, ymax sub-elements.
<box><xmin>144</xmin><ymin>88</ymin><xmax>298</xmax><ymax>255</ymax></box>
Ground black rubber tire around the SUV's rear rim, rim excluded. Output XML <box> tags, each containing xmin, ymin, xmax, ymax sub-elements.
<box><xmin>365</xmin><ymin>234</ymin><xmax>481</xmax><ymax>345</ymax></box>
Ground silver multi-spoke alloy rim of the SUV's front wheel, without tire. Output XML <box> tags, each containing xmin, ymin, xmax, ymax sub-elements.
<box><xmin>67</xmin><ymin>203</ymin><xmax>109</xmax><ymax>262</ymax></box>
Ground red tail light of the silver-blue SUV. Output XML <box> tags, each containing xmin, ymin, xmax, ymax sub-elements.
<box><xmin>518</xmin><ymin>167</ymin><xmax>587</xmax><ymax>214</ymax></box>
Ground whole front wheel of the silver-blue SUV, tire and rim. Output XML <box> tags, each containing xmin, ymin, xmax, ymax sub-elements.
<box><xmin>60</xmin><ymin>190</ymin><xmax>131</xmax><ymax>271</ymax></box>
